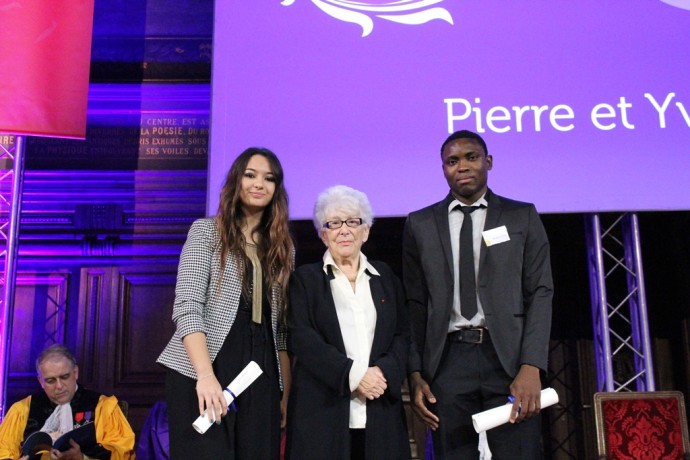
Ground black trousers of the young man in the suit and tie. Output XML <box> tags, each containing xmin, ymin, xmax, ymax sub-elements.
<box><xmin>429</xmin><ymin>332</ymin><xmax>542</xmax><ymax>460</ymax></box>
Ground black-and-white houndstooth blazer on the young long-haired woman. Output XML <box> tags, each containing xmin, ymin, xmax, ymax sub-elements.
<box><xmin>157</xmin><ymin>218</ymin><xmax>287</xmax><ymax>388</ymax></box>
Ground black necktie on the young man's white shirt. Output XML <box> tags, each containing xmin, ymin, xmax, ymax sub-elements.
<box><xmin>460</xmin><ymin>206</ymin><xmax>479</xmax><ymax>321</ymax></box>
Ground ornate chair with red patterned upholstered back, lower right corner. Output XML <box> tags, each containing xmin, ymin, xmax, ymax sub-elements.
<box><xmin>594</xmin><ymin>391</ymin><xmax>690</xmax><ymax>460</ymax></box>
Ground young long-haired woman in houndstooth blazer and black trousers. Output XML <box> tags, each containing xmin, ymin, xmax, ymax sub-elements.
<box><xmin>158</xmin><ymin>148</ymin><xmax>294</xmax><ymax>459</ymax></box>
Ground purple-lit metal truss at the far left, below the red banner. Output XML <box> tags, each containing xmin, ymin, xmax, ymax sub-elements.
<box><xmin>0</xmin><ymin>136</ymin><xmax>24</xmax><ymax>420</ymax></box>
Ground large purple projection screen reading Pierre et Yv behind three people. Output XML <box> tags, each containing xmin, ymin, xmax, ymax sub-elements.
<box><xmin>207</xmin><ymin>0</ymin><xmax>690</xmax><ymax>219</ymax></box>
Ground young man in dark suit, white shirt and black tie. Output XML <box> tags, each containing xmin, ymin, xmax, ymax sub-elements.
<box><xmin>403</xmin><ymin>131</ymin><xmax>553</xmax><ymax>459</ymax></box>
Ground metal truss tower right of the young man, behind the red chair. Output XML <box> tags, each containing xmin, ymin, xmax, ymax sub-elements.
<box><xmin>586</xmin><ymin>213</ymin><xmax>655</xmax><ymax>391</ymax></box>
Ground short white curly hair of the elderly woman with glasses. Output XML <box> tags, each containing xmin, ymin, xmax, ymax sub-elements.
<box><xmin>314</xmin><ymin>185</ymin><xmax>374</xmax><ymax>236</ymax></box>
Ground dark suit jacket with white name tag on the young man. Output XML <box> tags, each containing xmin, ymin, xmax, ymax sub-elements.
<box><xmin>403</xmin><ymin>190</ymin><xmax>553</xmax><ymax>382</ymax></box>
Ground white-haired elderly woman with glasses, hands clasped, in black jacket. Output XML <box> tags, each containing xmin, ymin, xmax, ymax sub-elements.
<box><xmin>286</xmin><ymin>185</ymin><xmax>410</xmax><ymax>460</ymax></box>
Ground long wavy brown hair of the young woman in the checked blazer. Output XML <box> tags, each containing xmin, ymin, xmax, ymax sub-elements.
<box><xmin>215</xmin><ymin>147</ymin><xmax>294</xmax><ymax>305</ymax></box>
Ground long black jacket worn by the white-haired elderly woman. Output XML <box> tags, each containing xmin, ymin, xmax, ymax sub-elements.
<box><xmin>286</xmin><ymin>260</ymin><xmax>410</xmax><ymax>460</ymax></box>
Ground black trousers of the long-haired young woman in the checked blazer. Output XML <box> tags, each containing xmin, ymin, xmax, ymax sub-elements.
<box><xmin>165</xmin><ymin>309</ymin><xmax>280</xmax><ymax>460</ymax></box>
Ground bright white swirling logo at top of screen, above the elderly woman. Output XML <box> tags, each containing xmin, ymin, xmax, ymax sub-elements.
<box><xmin>281</xmin><ymin>0</ymin><xmax>453</xmax><ymax>37</ymax></box>
